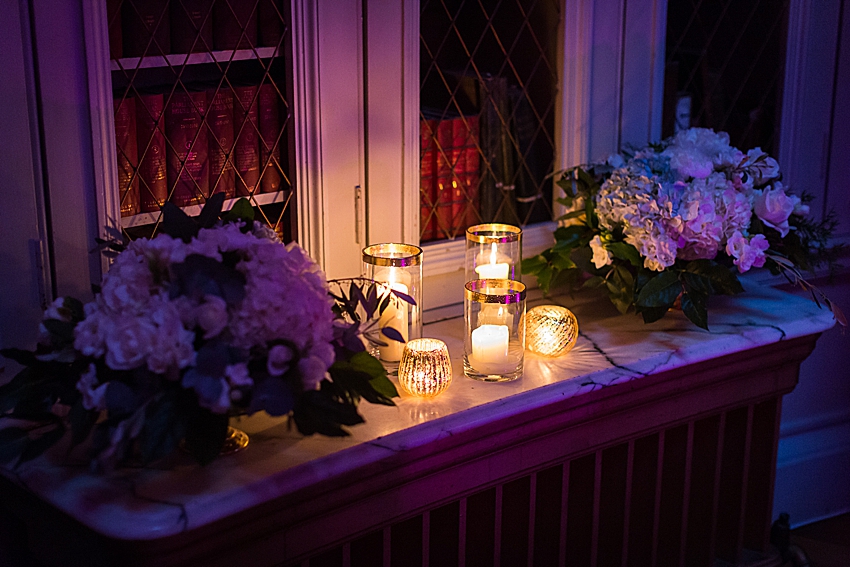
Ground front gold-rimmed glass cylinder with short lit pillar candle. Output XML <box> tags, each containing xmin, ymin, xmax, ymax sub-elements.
<box><xmin>463</xmin><ymin>279</ymin><xmax>525</xmax><ymax>382</ymax></box>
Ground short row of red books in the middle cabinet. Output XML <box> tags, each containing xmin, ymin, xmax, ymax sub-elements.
<box><xmin>419</xmin><ymin>116</ymin><xmax>480</xmax><ymax>241</ymax></box>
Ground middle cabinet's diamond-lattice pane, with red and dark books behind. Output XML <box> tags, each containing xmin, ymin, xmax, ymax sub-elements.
<box><xmin>420</xmin><ymin>0</ymin><xmax>561</xmax><ymax>242</ymax></box>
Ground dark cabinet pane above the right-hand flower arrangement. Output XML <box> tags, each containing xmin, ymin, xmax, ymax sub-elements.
<box><xmin>662</xmin><ymin>0</ymin><xmax>789</xmax><ymax>155</ymax></box>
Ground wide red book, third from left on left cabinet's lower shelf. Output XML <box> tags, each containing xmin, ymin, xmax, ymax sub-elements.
<box><xmin>165</xmin><ymin>91</ymin><xmax>209</xmax><ymax>207</ymax></box>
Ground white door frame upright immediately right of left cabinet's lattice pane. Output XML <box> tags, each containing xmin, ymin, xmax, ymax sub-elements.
<box><xmin>300</xmin><ymin>0</ymin><xmax>363</xmax><ymax>278</ymax></box>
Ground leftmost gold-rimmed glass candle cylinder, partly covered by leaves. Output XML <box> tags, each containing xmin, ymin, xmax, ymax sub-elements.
<box><xmin>363</xmin><ymin>243</ymin><xmax>422</xmax><ymax>363</ymax></box>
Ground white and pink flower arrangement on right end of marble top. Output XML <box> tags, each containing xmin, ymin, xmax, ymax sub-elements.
<box><xmin>522</xmin><ymin>128</ymin><xmax>846</xmax><ymax>329</ymax></box>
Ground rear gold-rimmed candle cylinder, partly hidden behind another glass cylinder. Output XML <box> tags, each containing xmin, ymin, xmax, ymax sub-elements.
<box><xmin>465</xmin><ymin>223</ymin><xmax>522</xmax><ymax>281</ymax></box>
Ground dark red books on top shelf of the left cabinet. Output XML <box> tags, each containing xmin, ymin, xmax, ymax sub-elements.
<box><xmin>107</xmin><ymin>0</ymin><xmax>283</xmax><ymax>59</ymax></box>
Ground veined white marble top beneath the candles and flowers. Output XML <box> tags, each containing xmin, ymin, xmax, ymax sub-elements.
<box><xmin>2</xmin><ymin>285</ymin><xmax>834</xmax><ymax>540</ymax></box>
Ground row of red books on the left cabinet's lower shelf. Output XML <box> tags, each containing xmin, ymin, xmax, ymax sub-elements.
<box><xmin>114</xmin><ymin>84</ymin><xmax>285</xmax><ymax>216</ymax></box>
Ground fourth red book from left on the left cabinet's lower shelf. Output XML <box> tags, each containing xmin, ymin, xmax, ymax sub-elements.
<box><xmin>207</xmin><ymin>87</ymin><xmax>236</xmax><ymax>199</ymax></box>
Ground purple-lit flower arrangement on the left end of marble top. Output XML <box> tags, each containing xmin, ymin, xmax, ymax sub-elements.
<box><xmin>0</xmin><ymin>195</ymin><xmax>400</xmax><ymax>470</ymax></box>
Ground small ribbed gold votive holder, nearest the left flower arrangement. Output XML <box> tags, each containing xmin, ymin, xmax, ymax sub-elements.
<box><xmin>398</xmin><ymin>339</ymin><xmax>452</xmax><ymax>398</ymax></box>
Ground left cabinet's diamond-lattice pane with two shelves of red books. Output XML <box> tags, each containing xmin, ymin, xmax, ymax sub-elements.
<box><xmin>107</xmin><ymin>0</ymin><xmax>296</xmax><ymax>241</ymax></box>
